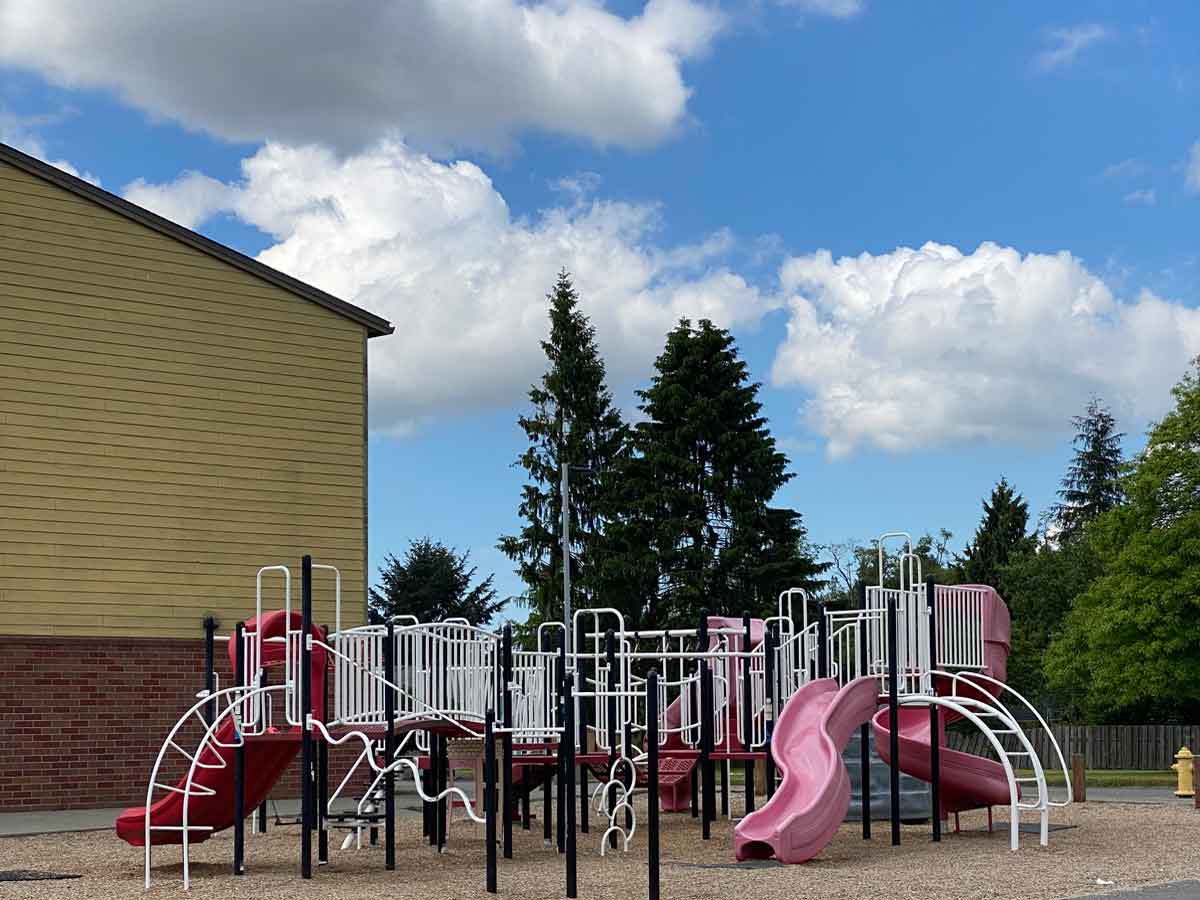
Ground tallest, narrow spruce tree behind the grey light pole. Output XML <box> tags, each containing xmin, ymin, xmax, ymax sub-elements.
<box><xmin>498</xmin><ymin>271</ymin><xmax>625</xmax><ymax>623</ymax></box>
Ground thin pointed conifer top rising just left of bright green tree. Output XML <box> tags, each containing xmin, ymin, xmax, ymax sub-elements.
<box><xmin>1052</xmin><ymin>397</ymin><xmax>1124</xmax><ymax>541</ymax></box>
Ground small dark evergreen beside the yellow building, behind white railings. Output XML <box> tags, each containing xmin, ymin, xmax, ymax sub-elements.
<box><xmin>370</xmin><ymin>538</ymin><xmax>504</xmax><ymax>626</ymax></box>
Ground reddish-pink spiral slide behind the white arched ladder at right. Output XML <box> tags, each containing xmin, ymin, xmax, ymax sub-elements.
<box><xmin>872</xmin><ymin>584</ymin><xmax>1012</xmax><ymax>815</ymax></box>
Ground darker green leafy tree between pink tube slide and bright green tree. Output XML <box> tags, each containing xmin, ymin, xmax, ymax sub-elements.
<box><xmin>1000</xmin><ymin>541</ymin><xmax>1100</xmax><ymax>709</ymax></box>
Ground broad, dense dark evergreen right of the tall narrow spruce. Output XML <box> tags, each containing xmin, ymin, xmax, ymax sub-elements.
<box><xmin>604</xmin><ymin>319</ymin><xmax>827</xmax><ymax>626</ymax></box>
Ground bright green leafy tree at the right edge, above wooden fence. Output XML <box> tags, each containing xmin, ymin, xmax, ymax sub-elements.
<box><xmin>1046</xmin><ymin>364</ymin><xmax>1200</xmax><ymax>719</ymax></box>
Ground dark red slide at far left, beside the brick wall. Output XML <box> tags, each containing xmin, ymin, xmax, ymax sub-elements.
<box><xmin>116</xmin><ymin>610</ymin><xmax>325</xmax><ymax>847</ymax></box>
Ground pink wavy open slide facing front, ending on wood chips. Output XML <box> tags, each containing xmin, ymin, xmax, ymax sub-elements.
<box><xmin>733</xmin><ymin>678</ymin><xmax>883</xmax><ymax>863</ymax></box>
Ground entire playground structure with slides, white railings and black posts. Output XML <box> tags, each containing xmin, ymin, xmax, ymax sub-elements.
<box><xmin>116</xmin><ymin>533</ymin><xmax>1072</xmax><ymax>899</ymax></box>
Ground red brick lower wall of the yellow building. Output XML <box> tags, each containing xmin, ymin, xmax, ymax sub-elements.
<box><xmin>0</xmin><ymin>636</ymin><xmax>367</xmax><ymax>812</ymax></box>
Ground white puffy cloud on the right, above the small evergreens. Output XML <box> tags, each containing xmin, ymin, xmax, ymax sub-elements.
<box><xmin>772</xmin><ymin>244</ymin><xmax>1200</xmax><ymax>457</ymax></box>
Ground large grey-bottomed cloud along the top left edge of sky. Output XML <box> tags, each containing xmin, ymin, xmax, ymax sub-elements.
<box><xmin>0</xmin><ymin>0</ymin><xmax>720</xmax><ymax>151</ymax></box>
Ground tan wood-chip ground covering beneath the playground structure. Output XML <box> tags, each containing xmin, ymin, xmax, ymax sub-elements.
<box><xmin>0</xmin><ymin>803</ymin><xmax>1196</xmax><ymax>900</ymax></box>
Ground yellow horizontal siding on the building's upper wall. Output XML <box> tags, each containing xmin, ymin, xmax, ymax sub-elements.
<box><xmin>0</xmin><ymin>163</ymin><xmax>366</xmax><ymax>637</ymax></box>
